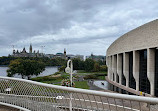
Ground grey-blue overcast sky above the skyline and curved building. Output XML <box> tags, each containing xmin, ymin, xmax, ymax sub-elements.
<box><xmin>0</xmin><ymin>0</ymin><xmax>158</xmax><ymax>56</ymax></box>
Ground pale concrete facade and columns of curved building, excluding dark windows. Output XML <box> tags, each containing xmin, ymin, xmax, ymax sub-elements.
<box><xmin>106</xmin><ymin>20</ymin><xmax>158</xmax><ymax>96</ymax></box>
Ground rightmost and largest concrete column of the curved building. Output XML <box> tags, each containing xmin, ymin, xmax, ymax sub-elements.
<box><xmin>147</xmin><ymin>49</ymin><xmax>155</xmax><ymax>96</ymax></box>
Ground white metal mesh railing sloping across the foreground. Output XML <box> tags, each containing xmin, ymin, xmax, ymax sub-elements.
<box><xmin>0</xmin><ymin>77</ymin><xmax>158</xmax><ymax>111</ymax></box>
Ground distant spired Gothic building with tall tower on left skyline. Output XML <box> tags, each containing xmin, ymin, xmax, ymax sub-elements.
<box><xmin>9</xmin><ymin>44</ymin><xmax>44</xmax><ymax>57</ymax></box>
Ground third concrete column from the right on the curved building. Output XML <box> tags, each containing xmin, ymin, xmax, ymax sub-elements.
<box><xmin>123</xmin><ymin>53</ymin><xmax>129</xmax><ymax>87</ymax></box>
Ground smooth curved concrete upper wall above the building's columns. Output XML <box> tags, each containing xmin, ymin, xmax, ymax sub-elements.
<box><xmin>106</xmin><ymin>20</ymin><xmax>158</xmax><ymax>56</ymax></box>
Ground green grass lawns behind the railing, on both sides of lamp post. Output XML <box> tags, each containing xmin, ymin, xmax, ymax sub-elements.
<box><xmin>32</xmin><ymin>70</ymin><xmax>107</xmax><ymax>89</ymax></box>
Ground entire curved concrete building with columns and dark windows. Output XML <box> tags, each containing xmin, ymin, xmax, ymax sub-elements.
<box><xmin>106</xmin><ymin>20</ymin><xmax>158</xmax><ymax>96</ymax></box>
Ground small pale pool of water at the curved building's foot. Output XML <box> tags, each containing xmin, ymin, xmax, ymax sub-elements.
<box><xmin>93</xmin><ymin>80</ymin><xmax>108</xmax><ymax>90</ymax></box>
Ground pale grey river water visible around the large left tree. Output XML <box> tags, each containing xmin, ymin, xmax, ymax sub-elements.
<box><xmin>0</xmin><ymin>67</ymin><xmax>58</xmax><ymax>78</ymax></box>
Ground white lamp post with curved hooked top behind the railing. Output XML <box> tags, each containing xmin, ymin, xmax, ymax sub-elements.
<box><xmin>65</xmin><ymin>59</ymin><xmax>73</xmax><ymax>111</ymax></box>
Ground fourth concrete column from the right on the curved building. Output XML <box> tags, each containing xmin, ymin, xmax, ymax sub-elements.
<box><xmin>117</xmin><ymin>54</ymin><xmax>122</xmax><ymax>84</ymax></box>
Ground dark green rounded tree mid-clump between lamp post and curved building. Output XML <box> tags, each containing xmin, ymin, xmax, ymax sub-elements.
<box><xmin>84</xmin><ymin>59</ymin><xmax>95</xmax><ymax>71</ymax></box>
